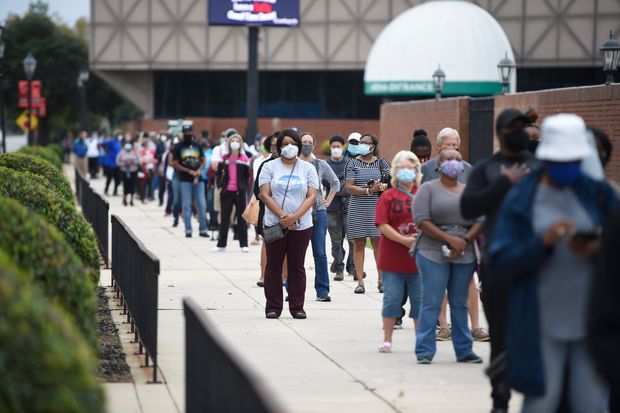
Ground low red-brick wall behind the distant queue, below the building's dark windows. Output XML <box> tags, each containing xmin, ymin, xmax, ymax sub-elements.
<box><xmin>123</xmin><ymin>118</ymin><xmax>379</xmax><ymax>154</ymax></box>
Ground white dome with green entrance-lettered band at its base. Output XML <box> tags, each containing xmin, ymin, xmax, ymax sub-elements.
<box><xmin>364</xmin><ymin>0</ymin><xmax>516</xmax><ymax>95</ymax></box>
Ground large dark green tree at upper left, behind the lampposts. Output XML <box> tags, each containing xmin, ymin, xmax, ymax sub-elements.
<box><xmin>3</xmin><ymin>0</ymin><xmax>137</xmax><ymax>141</ymax></box>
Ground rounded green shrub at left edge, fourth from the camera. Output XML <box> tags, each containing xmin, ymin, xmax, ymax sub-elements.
<box><xmin>0</xmin><ymin>153</ymin><xmax>73</xmax><ymax>202</ymax></box>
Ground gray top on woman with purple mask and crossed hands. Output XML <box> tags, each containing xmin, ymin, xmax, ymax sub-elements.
<box><xmin>413</xmin><ymin>179</ymin><xmax>477</xmax><ymax>264</ymax></box>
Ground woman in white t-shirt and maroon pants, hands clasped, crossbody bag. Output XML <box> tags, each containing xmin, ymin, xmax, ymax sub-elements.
<box><xmin>258</xmin><ymin>129</ymin><xmax>319</xmax><ymax>319</ymax></box>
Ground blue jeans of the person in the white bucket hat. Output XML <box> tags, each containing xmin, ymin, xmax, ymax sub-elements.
<box><xmin>521</xmin><ymin>335</ymin><xmax>609</xmax><ymax>413</ymax></box>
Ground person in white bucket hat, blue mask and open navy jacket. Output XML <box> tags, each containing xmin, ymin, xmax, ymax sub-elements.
<box><xmin>489</xmin><ymin>114</ymin><xmax>619</xmax><ymax>413</ymax></box>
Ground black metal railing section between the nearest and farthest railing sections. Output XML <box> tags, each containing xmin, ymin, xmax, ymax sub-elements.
<box><xmin>112</xmin><ymin>215</ymin><xmax>159</xmax><ymax>383</ymax></box>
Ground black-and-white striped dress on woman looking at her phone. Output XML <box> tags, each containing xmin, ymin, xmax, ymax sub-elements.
<box><xmin>345</xmin><ymin>158</ymin><xmax>390</xmax><ymax>239</ymax></box>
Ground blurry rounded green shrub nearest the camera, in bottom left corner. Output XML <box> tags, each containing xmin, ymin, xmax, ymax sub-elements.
<box><xmin>0</xmin><ymin>254</ymin><xmax>104</xmax><ymax>413</ymax></box>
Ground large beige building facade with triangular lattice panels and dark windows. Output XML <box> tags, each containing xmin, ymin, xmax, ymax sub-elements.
<box><xmin>90</xmin><ymin>0</ymin><xmax>620</xmax><ymax>119</ymax></box>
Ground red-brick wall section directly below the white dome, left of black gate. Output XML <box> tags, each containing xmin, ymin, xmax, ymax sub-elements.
<box><xmin>379</xmin><ymin>97</ymin><xmax>469</xmax><ymax>161</ymax></box>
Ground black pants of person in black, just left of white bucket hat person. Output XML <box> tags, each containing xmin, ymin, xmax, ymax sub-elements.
<box><xmin>479</xmin><ymin>264</ymin><xmax>510</xmax><ymax>408</ymax></box>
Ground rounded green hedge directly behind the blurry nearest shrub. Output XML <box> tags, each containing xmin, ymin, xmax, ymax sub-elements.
<box><xmin>0</xmin><ymin>197</ymin><xmax>97</xmax><ymax>348</ymax></box>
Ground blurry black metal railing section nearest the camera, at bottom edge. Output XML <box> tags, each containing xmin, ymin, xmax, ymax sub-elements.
<box><xmin>183</xmin><ymin>298</ymin><xmax>284</xmax><ymax>413</ymax></box>
